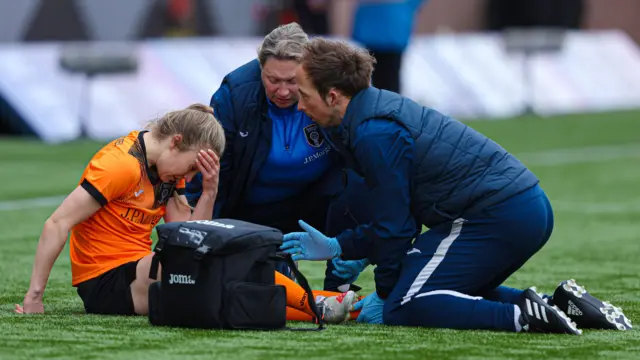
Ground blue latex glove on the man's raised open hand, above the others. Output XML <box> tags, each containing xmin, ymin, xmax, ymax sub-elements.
<box><xmin>280</xmin><ymin>220</ymin><xmax>342</xmax><ymax>261</ymax></box>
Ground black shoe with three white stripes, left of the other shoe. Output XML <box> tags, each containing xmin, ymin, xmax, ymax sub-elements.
<box><xmin>518</xmin><ymin>287</ymin><xmax>582</xmax><ymax>335</ymax></box>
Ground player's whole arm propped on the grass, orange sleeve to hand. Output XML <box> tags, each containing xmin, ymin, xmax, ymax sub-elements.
<box><xmin>16</xmin><ymin>156</ymin><xmax>139</xmax><ymax>313</ymax></box>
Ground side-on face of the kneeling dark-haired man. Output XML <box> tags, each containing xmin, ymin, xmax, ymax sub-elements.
<box><xmin>296</xmin><ymin>66</ymin><xmax>340</xmax><ymax>127</ymax></box>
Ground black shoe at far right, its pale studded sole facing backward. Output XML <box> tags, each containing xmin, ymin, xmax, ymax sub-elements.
<box><xmin>553</xmin><ymin>279</ymin><xmax>631</xmax><ymax>330</ymax></box>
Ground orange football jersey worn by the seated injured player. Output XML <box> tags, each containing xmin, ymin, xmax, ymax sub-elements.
<box><xmin>70</xmin><ymin>131</ymin><xmax>185</xmax><ymax>286</ymax></box>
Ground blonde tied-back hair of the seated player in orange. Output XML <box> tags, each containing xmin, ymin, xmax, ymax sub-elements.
<box><xmin>147</xmin><ymin>104</ymin><xmax>226</xmax><ymax>157</ymax></box>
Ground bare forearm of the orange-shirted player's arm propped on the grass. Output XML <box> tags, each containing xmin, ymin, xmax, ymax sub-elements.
<box><xmin>28</xmin><ymin>220</ymin><xmax>69</xmax><ymax>297</ymax></box>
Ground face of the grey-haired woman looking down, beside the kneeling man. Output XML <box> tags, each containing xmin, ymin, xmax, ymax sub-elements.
<box><xmin>262</xmin><ymin>58</ymin><xmax>298</xmax><ymax>108</ymax></box>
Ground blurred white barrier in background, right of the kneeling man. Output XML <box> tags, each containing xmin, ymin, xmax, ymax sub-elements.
<box><xmin>402</xmin><ymin>31</ymin><xmax>640</xmax><ymax>118</ymax></box>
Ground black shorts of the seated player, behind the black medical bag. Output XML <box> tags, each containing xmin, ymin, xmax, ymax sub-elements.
<box><xmin>77</xmin><ymin>260</ymin><xmax>139</xmax><ymax>315</ymax></box>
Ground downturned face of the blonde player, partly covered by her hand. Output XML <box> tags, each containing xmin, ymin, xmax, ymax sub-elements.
<box><xmin>156</xmin><ymin>143</ymin><xmax>198</xmax><ymax>182</ymax></box>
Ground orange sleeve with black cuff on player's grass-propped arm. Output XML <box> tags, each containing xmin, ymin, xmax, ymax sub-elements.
<box><xmin>80</xmin><ymin>154</ymin><xmax>140</xmax><ymax>206</ymax></box>
